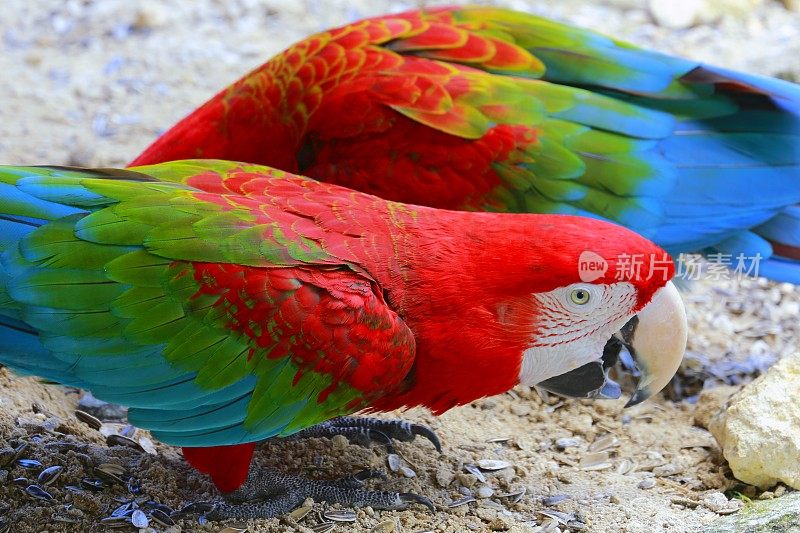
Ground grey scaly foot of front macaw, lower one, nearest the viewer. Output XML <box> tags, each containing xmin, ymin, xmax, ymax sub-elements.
<box><xmin>179</xmin><ymin>468</ymin><xmax>435</xmax><ymax>520</ymax></box>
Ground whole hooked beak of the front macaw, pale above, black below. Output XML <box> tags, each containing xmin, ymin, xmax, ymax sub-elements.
<box><xmin>536</xmin><ymin>282</ymin><xmax>688</xmax><ymax>407</ymax></box>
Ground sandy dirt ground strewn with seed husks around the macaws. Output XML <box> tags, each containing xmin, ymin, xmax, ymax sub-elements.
<box><xmin>0</xmin><ymin>0</ymin><xmax>800</xmax><ymax>533</ymax></box>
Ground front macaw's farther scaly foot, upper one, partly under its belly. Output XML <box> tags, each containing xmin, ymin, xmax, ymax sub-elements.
<box><xmin>292</xmin><ymin>416</ymin><xmax>442</xmax><ymax>453</ymax></box>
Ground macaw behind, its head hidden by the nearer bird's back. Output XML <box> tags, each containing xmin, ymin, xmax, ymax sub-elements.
<box><xmin>133</xmin><ymin>7</ymin><xmax>800</xmax><ymax>282</ymax></box>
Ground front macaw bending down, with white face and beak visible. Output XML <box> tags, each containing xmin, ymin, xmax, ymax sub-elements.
<box><xmin>0</xmin><ymin>160</ymin><xmax>686</xmax><ymax>516</ymax></box>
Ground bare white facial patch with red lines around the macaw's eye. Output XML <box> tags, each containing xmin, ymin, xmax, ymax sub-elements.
<box><xmin>519</xmin><ymin>282</ymin><xmax>636</xmax><ymax>386</ymax></box>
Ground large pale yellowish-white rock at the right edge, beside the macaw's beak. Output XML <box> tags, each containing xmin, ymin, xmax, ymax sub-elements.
<box><xmin>709</xmin><ymin>353</ymin><xmax>800</xmax><ymax>489</ymax></box>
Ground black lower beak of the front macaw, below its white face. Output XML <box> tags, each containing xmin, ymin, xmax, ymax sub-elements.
<box><xmin>536</xmin><ymin>337</ymin><xmax>622</xmax><ymax>400</ymax></box>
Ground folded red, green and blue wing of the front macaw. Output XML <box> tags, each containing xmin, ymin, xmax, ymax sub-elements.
<box><xmin>0</xmin><ymin>163</ymin><xmax>414</xmax><ymax>446</ymax></box>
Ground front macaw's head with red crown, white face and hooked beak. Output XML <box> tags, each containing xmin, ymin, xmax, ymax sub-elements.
<box><xmin>504</xmin><ymin>216</ymin><xmax>688</xmax><ymax>405</ymax></box>
